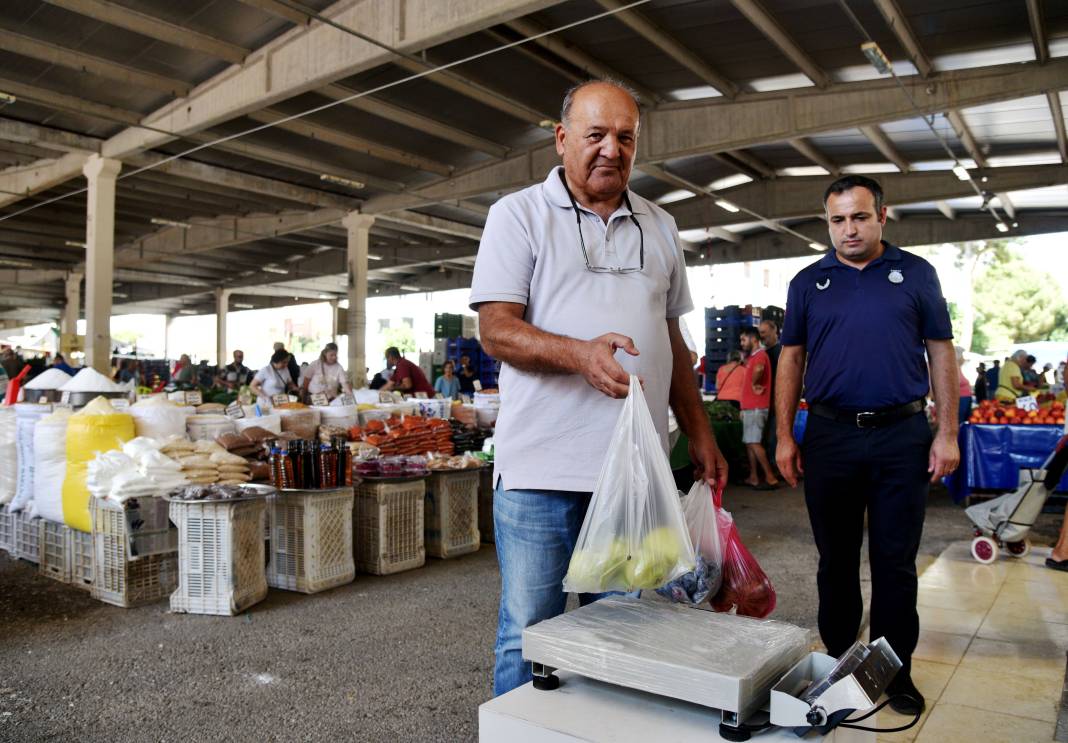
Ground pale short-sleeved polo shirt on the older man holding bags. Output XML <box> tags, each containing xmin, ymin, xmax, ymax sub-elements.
<box><xmin>470</xmin><ymin>167</ymin><xmax>693</xmax><ymax>492</ymax></box>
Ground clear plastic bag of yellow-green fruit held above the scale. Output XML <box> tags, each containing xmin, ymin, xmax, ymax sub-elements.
<box><xmin>564</xmin><ymin>375</ymin><xmax>695</xmax><ymax>594</ymax></box>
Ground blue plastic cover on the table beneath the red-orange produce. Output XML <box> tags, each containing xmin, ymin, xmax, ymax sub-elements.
<box><xmin>943</xmin><ymin>423</ymin><xmax>1068</xmax><ymax>503</ymax></box>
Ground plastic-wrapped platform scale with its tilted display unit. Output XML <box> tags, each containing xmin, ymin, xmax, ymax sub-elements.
<box><xmin>523</xmin><ymin>596</ymin><xmax>900</xmax><ymax>741</ymax></box>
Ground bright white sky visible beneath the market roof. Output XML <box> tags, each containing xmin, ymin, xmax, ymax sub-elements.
<box><xmin>0</xmin><ymin>233</ymin><xmax>1068</xmax><ymax>375</ymax></box>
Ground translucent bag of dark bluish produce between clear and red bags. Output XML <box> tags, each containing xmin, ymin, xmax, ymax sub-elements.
<box><xmin>657</xmin><ymin>481</ymin><xmax>723</xmax><ymax>604</ymax></box>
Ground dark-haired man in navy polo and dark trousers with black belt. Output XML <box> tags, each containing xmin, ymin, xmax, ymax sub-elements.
<box><xmin>775</xmin><ymin>175</ymin><xmax>960</xmax><ymax>714</ymax></box>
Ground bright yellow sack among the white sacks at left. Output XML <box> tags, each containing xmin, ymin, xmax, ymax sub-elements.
<box><xmin>63</xmin><ymin>397</ymin><xmax>136</xmax><ymax>532</ymax></box>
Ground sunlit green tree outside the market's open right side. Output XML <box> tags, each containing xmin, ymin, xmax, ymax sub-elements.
<box><xmin>973</xmin><ymin>251</ymin><xmax>1068</xmax><ymax>352</ymax></box>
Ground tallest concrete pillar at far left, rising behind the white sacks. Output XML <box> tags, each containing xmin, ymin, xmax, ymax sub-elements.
<box><xmin>82</xmin><ymin>155</ymin><xmax>123</xmax><ymax>374</ymax></box>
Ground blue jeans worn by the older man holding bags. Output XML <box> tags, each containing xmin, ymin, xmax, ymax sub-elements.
<box><xmin>493</xmin><ymin>480</ymin><xmax>604</xmax><ymax>696</ymax></box>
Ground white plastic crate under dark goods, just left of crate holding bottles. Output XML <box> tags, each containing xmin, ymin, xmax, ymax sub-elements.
<box><xmin>170</xmin><ymin>497</ymin><xmax>267</xmax><ymax>616</ymax></box>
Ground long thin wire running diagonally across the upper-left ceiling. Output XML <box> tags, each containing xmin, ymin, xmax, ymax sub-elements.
<box><xmin>0</xmin><ymin>0</ymin><xmax>649</xmax><ymax>222</ymax></box>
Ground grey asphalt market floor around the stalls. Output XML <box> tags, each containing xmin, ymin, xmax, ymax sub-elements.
<box><xmin>0</xmin><ymin>489</ymin><xmax>1061</xmax><ymax>741</ymax></box>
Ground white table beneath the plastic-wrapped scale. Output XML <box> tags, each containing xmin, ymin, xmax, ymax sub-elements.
<box><xmin>478</xmin><ymin>670</ymin><xmax>878</xmax><ymax>743</ymax></box>
